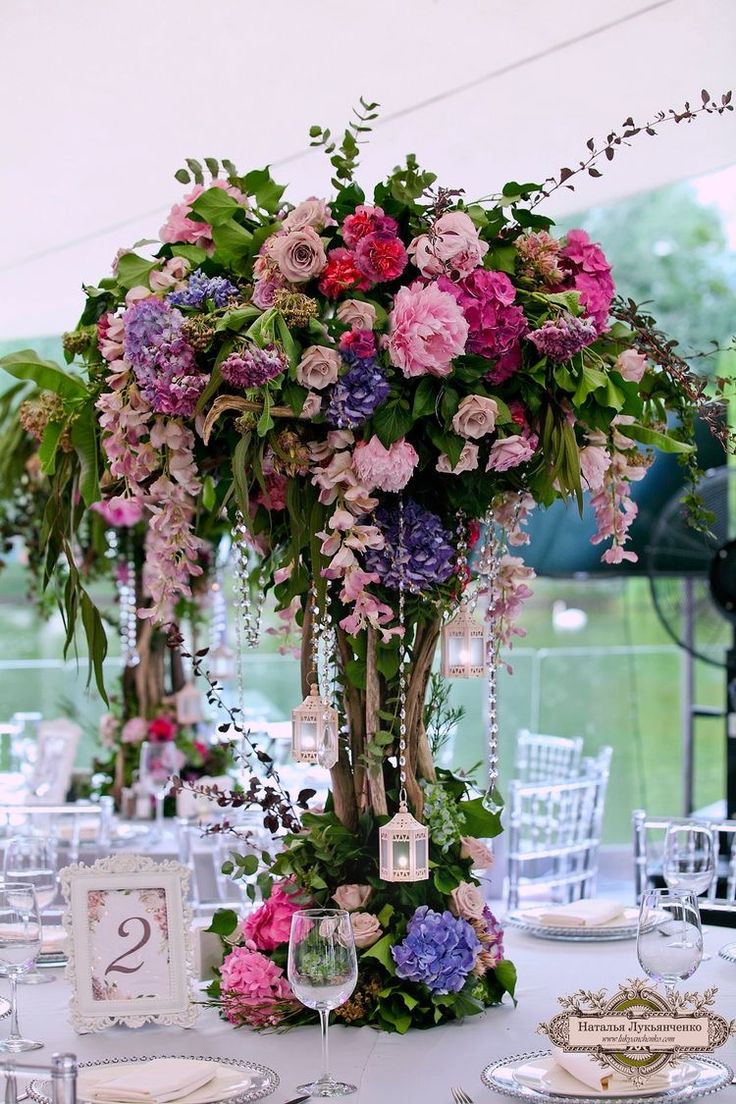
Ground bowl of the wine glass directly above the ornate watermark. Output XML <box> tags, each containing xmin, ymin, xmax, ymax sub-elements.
<box><xmin>637</xmin><ymin>890</ymin><xmax>703</xmax><ymax>986</ymax></box>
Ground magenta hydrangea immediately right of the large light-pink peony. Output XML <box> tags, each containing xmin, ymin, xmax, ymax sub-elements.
<box><xmin>437</xmin><ymin>268</ymin><xmax>527</xmax><ymax>359</ymax></box>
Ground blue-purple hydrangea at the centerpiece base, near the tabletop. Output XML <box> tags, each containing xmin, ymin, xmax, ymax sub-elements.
<box><xmin>391</xmin><ymin>904</ymin><xmax>481</xmax><ymax>992</ymax></box>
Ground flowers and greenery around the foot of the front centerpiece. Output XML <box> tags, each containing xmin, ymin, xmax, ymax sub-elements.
<box><xmin>207</xmin><ymin>771</ymin><xmax>516</xmax><ymax>1033</ymax></box>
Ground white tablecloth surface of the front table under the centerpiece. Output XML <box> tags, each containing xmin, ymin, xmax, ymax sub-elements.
<box><xmin>15</xmin><ymin>927</ymin><xmax>736</xmax><ymax>1104</ymax></box>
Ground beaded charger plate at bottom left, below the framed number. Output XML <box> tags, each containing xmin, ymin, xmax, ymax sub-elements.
<box><xmin>29</xmin><ymin>1054</ymin><xmax>279</xmax><ymax>1104</ymax></box>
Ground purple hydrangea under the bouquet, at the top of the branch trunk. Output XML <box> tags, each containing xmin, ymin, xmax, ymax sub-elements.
<box><xmin>365</xmin><ymin>499</ymin><xmax>455</xmax><ymax>591</ymax></box>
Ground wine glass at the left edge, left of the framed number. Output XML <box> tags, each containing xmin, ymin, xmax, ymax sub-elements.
<box><xmin>0</xmin><ymin>882</ymin><xmax>43</xmax><ymax>1054</ymax></box>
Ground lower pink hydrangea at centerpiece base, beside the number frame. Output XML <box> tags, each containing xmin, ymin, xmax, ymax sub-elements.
<box><xmin>221</xmin><ymin>943</ymin><xmax>294</xmax><ymax>1027</ymax></box>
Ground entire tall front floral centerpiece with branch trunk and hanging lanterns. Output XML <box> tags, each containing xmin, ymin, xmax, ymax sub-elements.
<box><xmin>2</xmin><ymin>94</ymin><xmax>730</xmax><ymax>1031</ymax></box>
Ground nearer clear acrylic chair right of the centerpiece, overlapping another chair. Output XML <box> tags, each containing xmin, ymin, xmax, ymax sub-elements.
<box><xmin>506</xmin><ymin>747</ymin><xmax>612</xmax><ymax>909</ymax></box>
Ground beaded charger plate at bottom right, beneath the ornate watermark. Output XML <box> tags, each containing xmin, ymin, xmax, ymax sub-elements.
<box><xmin>480</xmin><ymin>1050</ymin><xmax>734</xmax><ymax>1104</ymax></box>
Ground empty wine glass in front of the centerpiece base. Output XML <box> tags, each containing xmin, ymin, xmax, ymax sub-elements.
<box><xmin>288</xmin><ymin>909</ymin><xmax>358</xmax><ymax>1096</ymax></box>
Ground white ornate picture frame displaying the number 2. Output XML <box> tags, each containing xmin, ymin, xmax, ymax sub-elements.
<box><xmin>61</xmin><ymin>854</ymin><xmax>198</xmax><ymax>1034</ymax></box>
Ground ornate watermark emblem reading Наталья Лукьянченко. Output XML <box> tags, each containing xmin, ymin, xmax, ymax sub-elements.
<box><xmin>537</xmin><ymin>978</ymin><xmax>736</xmax><ymax>1086</ymax></box>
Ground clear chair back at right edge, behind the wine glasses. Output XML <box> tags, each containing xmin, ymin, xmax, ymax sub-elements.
<box><xmin>631</xmin><ymin>809</ymin><xmax>736</xmax><ymax>912</ymax></box>
